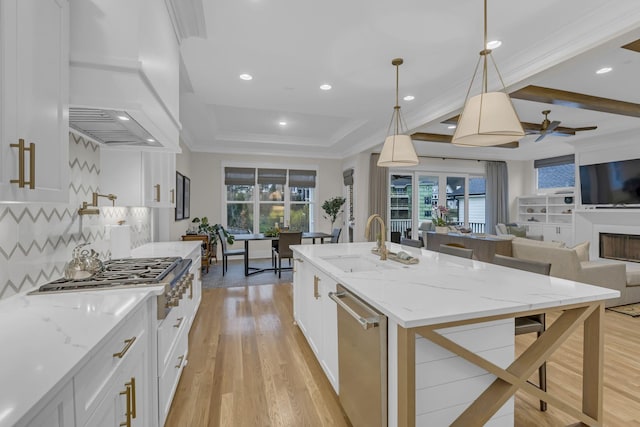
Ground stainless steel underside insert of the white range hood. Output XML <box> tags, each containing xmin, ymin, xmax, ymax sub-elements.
<box><xmin>69</xmin><ymin>107</ymin><xmax>161</xmax><ymax>147</ymax></box>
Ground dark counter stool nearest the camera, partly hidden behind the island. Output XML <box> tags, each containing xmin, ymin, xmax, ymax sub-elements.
<box><xmin>493</xmin><ymin>254</ymin><xmax>551</xmax><ymax>412</ymax></box>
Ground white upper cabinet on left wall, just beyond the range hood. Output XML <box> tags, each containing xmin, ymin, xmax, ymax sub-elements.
<box><xmin>100</xmin><ymin>149</ymin><xmax>176</xmax><ymax>208</ymax></box>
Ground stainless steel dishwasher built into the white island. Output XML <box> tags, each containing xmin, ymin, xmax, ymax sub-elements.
<box><xmin>329</xmin><ymin>284</ymin><xmax>387</xmax><ymax>427</ymax></box>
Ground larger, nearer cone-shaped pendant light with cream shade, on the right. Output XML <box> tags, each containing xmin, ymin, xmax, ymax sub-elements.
<box><xmin>451</xmin><ymin>0</ymin><xmax>524</xmax><ymax>147</ymax></box>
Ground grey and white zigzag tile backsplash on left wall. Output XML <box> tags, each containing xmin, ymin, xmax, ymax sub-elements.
<box><xmin>0</xmin><ymin>133</ymin><xmax>151</xmax><ymax>299</ymax></box>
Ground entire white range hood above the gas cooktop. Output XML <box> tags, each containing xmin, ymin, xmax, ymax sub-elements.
<box><xmin>69</xmin><ymin>0</ymin><xmax>181</xmax><ymax>152</ymax></box>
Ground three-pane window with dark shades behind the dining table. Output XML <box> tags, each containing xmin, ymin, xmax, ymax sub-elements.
<box><xmin>225</xmin><ymin>167</ymin><xmax>316</xmax><ymax>234</ymax></box>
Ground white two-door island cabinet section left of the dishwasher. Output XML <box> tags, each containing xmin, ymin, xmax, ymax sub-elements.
<box><xmin>293</xmin><ymin>258</ymin><xmax>338</xmax><ymax>392</ymax></box>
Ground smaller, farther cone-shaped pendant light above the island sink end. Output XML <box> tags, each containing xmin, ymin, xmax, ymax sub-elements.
<box><xmin>378</xmin><ymin>58</ymin><xmax>418</xmax><ymax>168</ymax></box>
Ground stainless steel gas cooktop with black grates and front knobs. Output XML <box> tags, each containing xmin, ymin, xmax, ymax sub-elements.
<box><xmin>29</xmin><ymin>257</ymin><xmax>193</xmax><ymax>319</ymax></box>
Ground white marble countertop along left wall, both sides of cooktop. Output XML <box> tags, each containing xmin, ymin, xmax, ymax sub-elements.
<box><xmin>0</xmin><ymin>241</ymin><xmax>199</xmax><ymax>427</ymax></box>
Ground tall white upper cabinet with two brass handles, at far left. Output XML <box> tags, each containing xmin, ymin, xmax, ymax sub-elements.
<box><xmin>0</xmin><ymin>0</ymin><xmax>69</xmax><ymax>202</ymax></box>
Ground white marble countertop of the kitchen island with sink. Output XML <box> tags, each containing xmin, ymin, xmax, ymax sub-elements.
<box><xmin>292</xmin><ymin>242</ymin><xmax>620</xmax><ymax>328</ymax></box>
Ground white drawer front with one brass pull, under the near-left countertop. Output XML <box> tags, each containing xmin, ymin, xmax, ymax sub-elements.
<box><xmin>73</xmin><ymin>304</ymin><xmax>149</xmax><ymax>425</ymax></box>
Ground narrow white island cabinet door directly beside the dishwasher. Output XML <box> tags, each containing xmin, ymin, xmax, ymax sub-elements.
<box><xmin>321</xmin><ymin>275</ymin><xmax>339</xmax><ymax>393</ymax></box>
